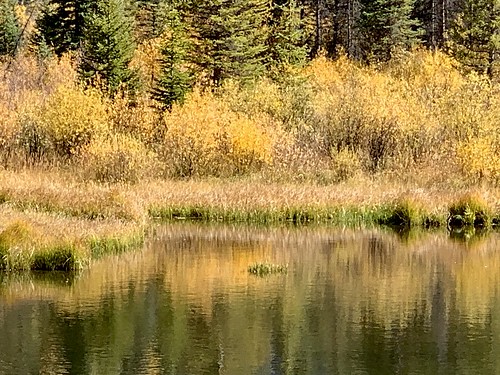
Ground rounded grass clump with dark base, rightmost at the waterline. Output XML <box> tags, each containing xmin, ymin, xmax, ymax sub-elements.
<box><xmin>448</xmin><ymin>194</ymin><xmax>492</xmax><ymax>228</ymax></box>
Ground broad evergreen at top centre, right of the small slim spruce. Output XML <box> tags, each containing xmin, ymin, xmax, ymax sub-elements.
<box><xmin>190</xmin><ymin>0</ymin><xmax>269</xmax><ymax>86</ymax></box>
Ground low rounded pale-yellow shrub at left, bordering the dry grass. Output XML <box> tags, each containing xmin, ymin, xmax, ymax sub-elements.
<box><xmin>83</xmin><ymin>134</ymin><xmax>154</xmax><ymax>182</ymax></box>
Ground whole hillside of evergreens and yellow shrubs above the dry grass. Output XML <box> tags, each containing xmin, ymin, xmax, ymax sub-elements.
<box><xmin>0</xmin><ymin>0</ymin><xmax>500</xmax><ymax>184</ymax></box>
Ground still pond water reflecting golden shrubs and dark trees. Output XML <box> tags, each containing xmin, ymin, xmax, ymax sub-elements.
<box><xmin>0</xmin><ymin>223</ymin><xmax>500</xmax><ymax>375</ymax></box>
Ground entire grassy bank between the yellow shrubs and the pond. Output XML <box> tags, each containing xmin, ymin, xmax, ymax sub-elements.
<box><xmin>0</xmin><ymin>169</ymin><xmax>500</xmax><ymax>270</ymax></box>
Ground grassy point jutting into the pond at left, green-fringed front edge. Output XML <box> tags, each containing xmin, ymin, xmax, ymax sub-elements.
<box><xmin>0</xmin><ymin>207</ymin><xmax>145</xmax><ymax>271</ymax></box>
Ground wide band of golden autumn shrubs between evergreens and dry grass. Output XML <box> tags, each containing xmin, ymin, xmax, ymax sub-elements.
<box><xmin>0</xmin><ymin>50</ymin><xmax>500</xmax><ymax>186</ymax></box>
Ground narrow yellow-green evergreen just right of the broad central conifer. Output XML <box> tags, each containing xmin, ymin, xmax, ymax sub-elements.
<box><xmin>267</xmin><ymin>0</ymin><xmax>307</xmax><ymax>68</ymax></box>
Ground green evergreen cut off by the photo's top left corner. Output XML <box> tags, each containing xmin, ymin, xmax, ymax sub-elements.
<box><xmin>0</xmin><ymin>0</ymin><xmax>21</xmax><ymax>56</ymax></box>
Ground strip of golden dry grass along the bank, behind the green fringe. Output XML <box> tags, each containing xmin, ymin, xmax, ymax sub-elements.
<box><xmin>0</xmin><ymin>169</ymin><xmax>500</xmax><ymax>225</ymax></box>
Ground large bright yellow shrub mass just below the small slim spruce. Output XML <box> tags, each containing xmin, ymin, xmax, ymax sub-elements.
<box><xmin>163</xmin><ymin>93</ymin><xmax>273</xmax><ymax>176</ymax></box>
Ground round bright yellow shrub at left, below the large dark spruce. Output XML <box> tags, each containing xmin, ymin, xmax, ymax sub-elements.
<box><xmin>41</xmin><ymin>86</ymin><xmax>108</xmax><ymax>157</ymax></box>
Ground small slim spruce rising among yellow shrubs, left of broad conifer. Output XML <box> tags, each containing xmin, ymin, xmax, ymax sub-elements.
<box><xmin>153</xmin><ymin>5</ymin><xmax>193</xmax><ymax>110</ymax></box>
